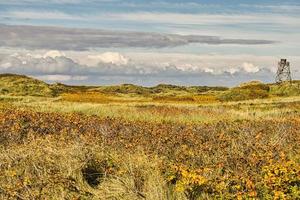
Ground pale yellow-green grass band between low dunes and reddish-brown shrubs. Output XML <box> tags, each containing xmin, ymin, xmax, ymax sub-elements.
<box><xmin>0</xmin><ymin>96</ymin><xmax>300</xmax><ymax>124</ymax></box>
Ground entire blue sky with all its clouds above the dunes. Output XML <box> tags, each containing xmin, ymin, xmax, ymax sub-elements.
<box><xmin>0</xmin><ymin>0</ymin><xmax>300</xmax><ymax>86</ymax></box>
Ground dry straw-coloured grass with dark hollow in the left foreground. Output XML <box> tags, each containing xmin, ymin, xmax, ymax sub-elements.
<box><xmin>0</xmin><ymin>136</ymin><xmax>180</xmax><ymax>200</ymax></box>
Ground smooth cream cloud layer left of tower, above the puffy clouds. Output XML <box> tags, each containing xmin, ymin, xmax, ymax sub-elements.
<box><xmin>126</xmin><ymin>52</ymin><xmax>282</xmax><ymax>74</ymax></box>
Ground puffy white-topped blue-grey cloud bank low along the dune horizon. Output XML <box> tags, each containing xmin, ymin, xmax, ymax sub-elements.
<box><xmin>0</xmin><ymin>51</ymin><xmax>282</xmax><ymax>86</ymax></box>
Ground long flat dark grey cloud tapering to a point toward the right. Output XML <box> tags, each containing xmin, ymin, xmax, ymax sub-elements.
<box><xmin>0</xmin><ymin>25</ymin><xmax>275</xmax><ymax>51</ymax></box>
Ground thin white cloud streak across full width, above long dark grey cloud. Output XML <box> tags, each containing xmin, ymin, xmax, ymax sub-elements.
<box><xmin>0</xmin><ymin>9</ymin><xmax>300</xmax><ymax>27</ymax></box>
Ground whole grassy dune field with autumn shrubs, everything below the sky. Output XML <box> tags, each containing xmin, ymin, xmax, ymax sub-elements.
<box><xmin>0</xmin><ymin>76</ymin><xmax>300</xmax><ymax>200</ymax></box>
